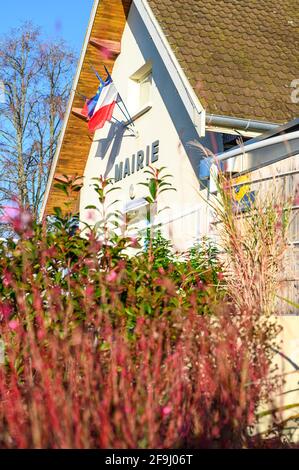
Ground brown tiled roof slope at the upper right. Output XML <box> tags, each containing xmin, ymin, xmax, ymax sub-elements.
<box><xmin>148</xmin><ymin>0</ymin><xmax>299</xmax><ymax>123</ymax></box>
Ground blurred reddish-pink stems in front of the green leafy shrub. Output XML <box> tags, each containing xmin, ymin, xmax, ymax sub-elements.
<box><xmin>0</xmin><ymin>291</ymin><xmax>278</xmax><ymax>448</ymax></box>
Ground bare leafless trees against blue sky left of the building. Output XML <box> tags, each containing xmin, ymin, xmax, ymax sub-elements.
<box><xmin>0</xmin><ymin>24</ymin><xmax>75</xmax><ymax>225</ymax></box>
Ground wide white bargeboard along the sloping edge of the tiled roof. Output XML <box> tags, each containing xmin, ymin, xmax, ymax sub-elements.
<box><xmin>133</xmin><ymin>0</ymin><xmax>206</xmax><ymax>137</ymax></box>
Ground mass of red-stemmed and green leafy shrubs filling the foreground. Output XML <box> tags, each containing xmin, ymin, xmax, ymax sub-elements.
<box><xmin>0</xmin><ymin>166</ymin><xmax>292</xmax><ymax>448</ymax></box>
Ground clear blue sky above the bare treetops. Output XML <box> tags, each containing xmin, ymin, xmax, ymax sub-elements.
<box><xmin>0</xmin><ymin>0</ymin><xmax>93</xmax><ymax>55</ymax></box>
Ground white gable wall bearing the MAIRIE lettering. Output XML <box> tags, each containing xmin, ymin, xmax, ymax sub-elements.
<box><xmin>80</xmin><ymin>4</ymin><xmax>221</xmax><ymax>249</ymax></box>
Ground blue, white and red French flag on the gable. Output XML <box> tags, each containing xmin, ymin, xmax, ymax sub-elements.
<box><xmin>82</xmin><ymin>75</ymin><xmax>119</xmax><ymax>132</ymax></box>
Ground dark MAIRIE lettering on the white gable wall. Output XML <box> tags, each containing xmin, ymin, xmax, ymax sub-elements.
<box><xmin>114</xmin><ymin>140</ymin><xmax>160</xmax><ymax>182</ymax></box>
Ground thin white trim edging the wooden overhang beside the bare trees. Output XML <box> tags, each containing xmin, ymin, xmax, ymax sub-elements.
<box><xmin>40</xmin><ymin>0</ymin><xmax>100</xmax><ymax>220</ymax></box>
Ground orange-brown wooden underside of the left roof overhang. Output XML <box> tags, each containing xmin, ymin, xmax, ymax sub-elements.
<box><xmin>42</xmin><ymin>0</ymin><xmax>132</xmax><ymax>217</ymax></box>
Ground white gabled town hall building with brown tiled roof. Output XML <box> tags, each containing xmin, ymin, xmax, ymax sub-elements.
<box><xmin>41</xmin><ymin>0</ymin><xmax>299</xmax><ymax>412</ymax></box>
